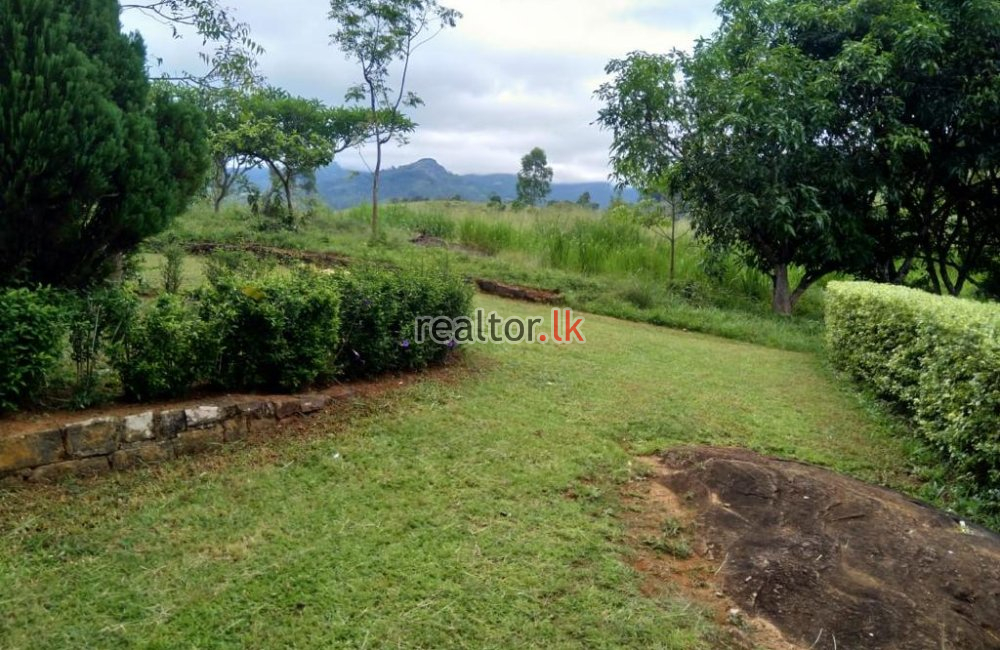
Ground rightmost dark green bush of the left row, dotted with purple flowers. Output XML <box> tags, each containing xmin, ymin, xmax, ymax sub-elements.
<box><xmin>337</xmin><ymin>266</ymin><xmax>473</xmax><ymax>376</ymax></box>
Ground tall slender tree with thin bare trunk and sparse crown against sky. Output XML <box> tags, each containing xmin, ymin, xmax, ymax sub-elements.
<box><xmin>330</xmin><ymin>0</ymin><xmax>462</xmax><ymax>239</ymax></box>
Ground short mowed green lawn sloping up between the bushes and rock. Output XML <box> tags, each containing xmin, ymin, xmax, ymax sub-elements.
<box><xmin>0</xmin><ymin>297</ymin><xmax>906</xmax><ymax>649</ymax></box>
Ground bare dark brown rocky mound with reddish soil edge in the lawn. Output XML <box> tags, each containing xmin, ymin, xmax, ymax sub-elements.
<box><xmin>638</xmin><ymin>448</ymin><xmax>1000</xmax><ymax>650</ymax></box>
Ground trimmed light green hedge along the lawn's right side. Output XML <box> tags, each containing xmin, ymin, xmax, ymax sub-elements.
<box><xmin>826</xmin><ymin>282</ymin><xmax>1000</xmax><ymax>494</ymax></box>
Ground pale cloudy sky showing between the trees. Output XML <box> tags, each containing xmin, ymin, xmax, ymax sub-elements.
<box><xmin>122</xmin><ymin>0</ymin><xmax>717</xmax><ymax>182</ymax></box>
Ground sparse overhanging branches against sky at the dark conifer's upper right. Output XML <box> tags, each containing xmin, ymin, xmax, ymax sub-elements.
<box><xmin>121</xmin><ymin>0</ymin><xmax>264</xmax><ymax>88</ymax></box>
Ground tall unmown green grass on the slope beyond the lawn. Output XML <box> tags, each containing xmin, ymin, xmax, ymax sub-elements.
<box><xmin>154</xmin><ymin>202</ymin><xmax>822</xmax><ymax>351</ymax></box>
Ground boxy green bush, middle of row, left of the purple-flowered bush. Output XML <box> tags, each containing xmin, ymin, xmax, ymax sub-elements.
<box><xmin>200</xmin><ymin>269</ymin><xmax>340</xmax><ymax>391</ymax></box>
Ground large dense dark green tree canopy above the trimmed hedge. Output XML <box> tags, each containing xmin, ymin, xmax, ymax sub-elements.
<box><xmin>597</xmin><ymin>0</ymin><xmax>1000</xmax><ymax>313</ymax></box>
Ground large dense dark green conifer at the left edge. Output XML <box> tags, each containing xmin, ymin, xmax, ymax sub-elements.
<box><xmin>0</xmin><ymin>0</ymin><xmax>208</xmax><ymax>286</ymax></box>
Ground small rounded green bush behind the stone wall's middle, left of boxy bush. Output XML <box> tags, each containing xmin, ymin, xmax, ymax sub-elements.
<box><xmin>112</xmin><ymin>294</ymin><xmax>218</xmax><ymax>401</ymax></box>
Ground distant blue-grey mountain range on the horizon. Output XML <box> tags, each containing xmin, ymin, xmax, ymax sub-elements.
<box><xmin>249</xmin><ymin>158</ymin><xmax>638</xmax><ymax>209</ymax></box>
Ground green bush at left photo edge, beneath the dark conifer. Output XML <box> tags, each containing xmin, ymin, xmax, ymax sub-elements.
<box><xmin>0</xmin><ymin>289</ymin><xmax>66</xmax><ymax>411</ymax></box>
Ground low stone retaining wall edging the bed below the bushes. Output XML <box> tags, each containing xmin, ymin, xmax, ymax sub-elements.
<box><xmin>0</xmin><ymin>395</ymin><xmax>333</xmax><ymax>484</ymax></box>
